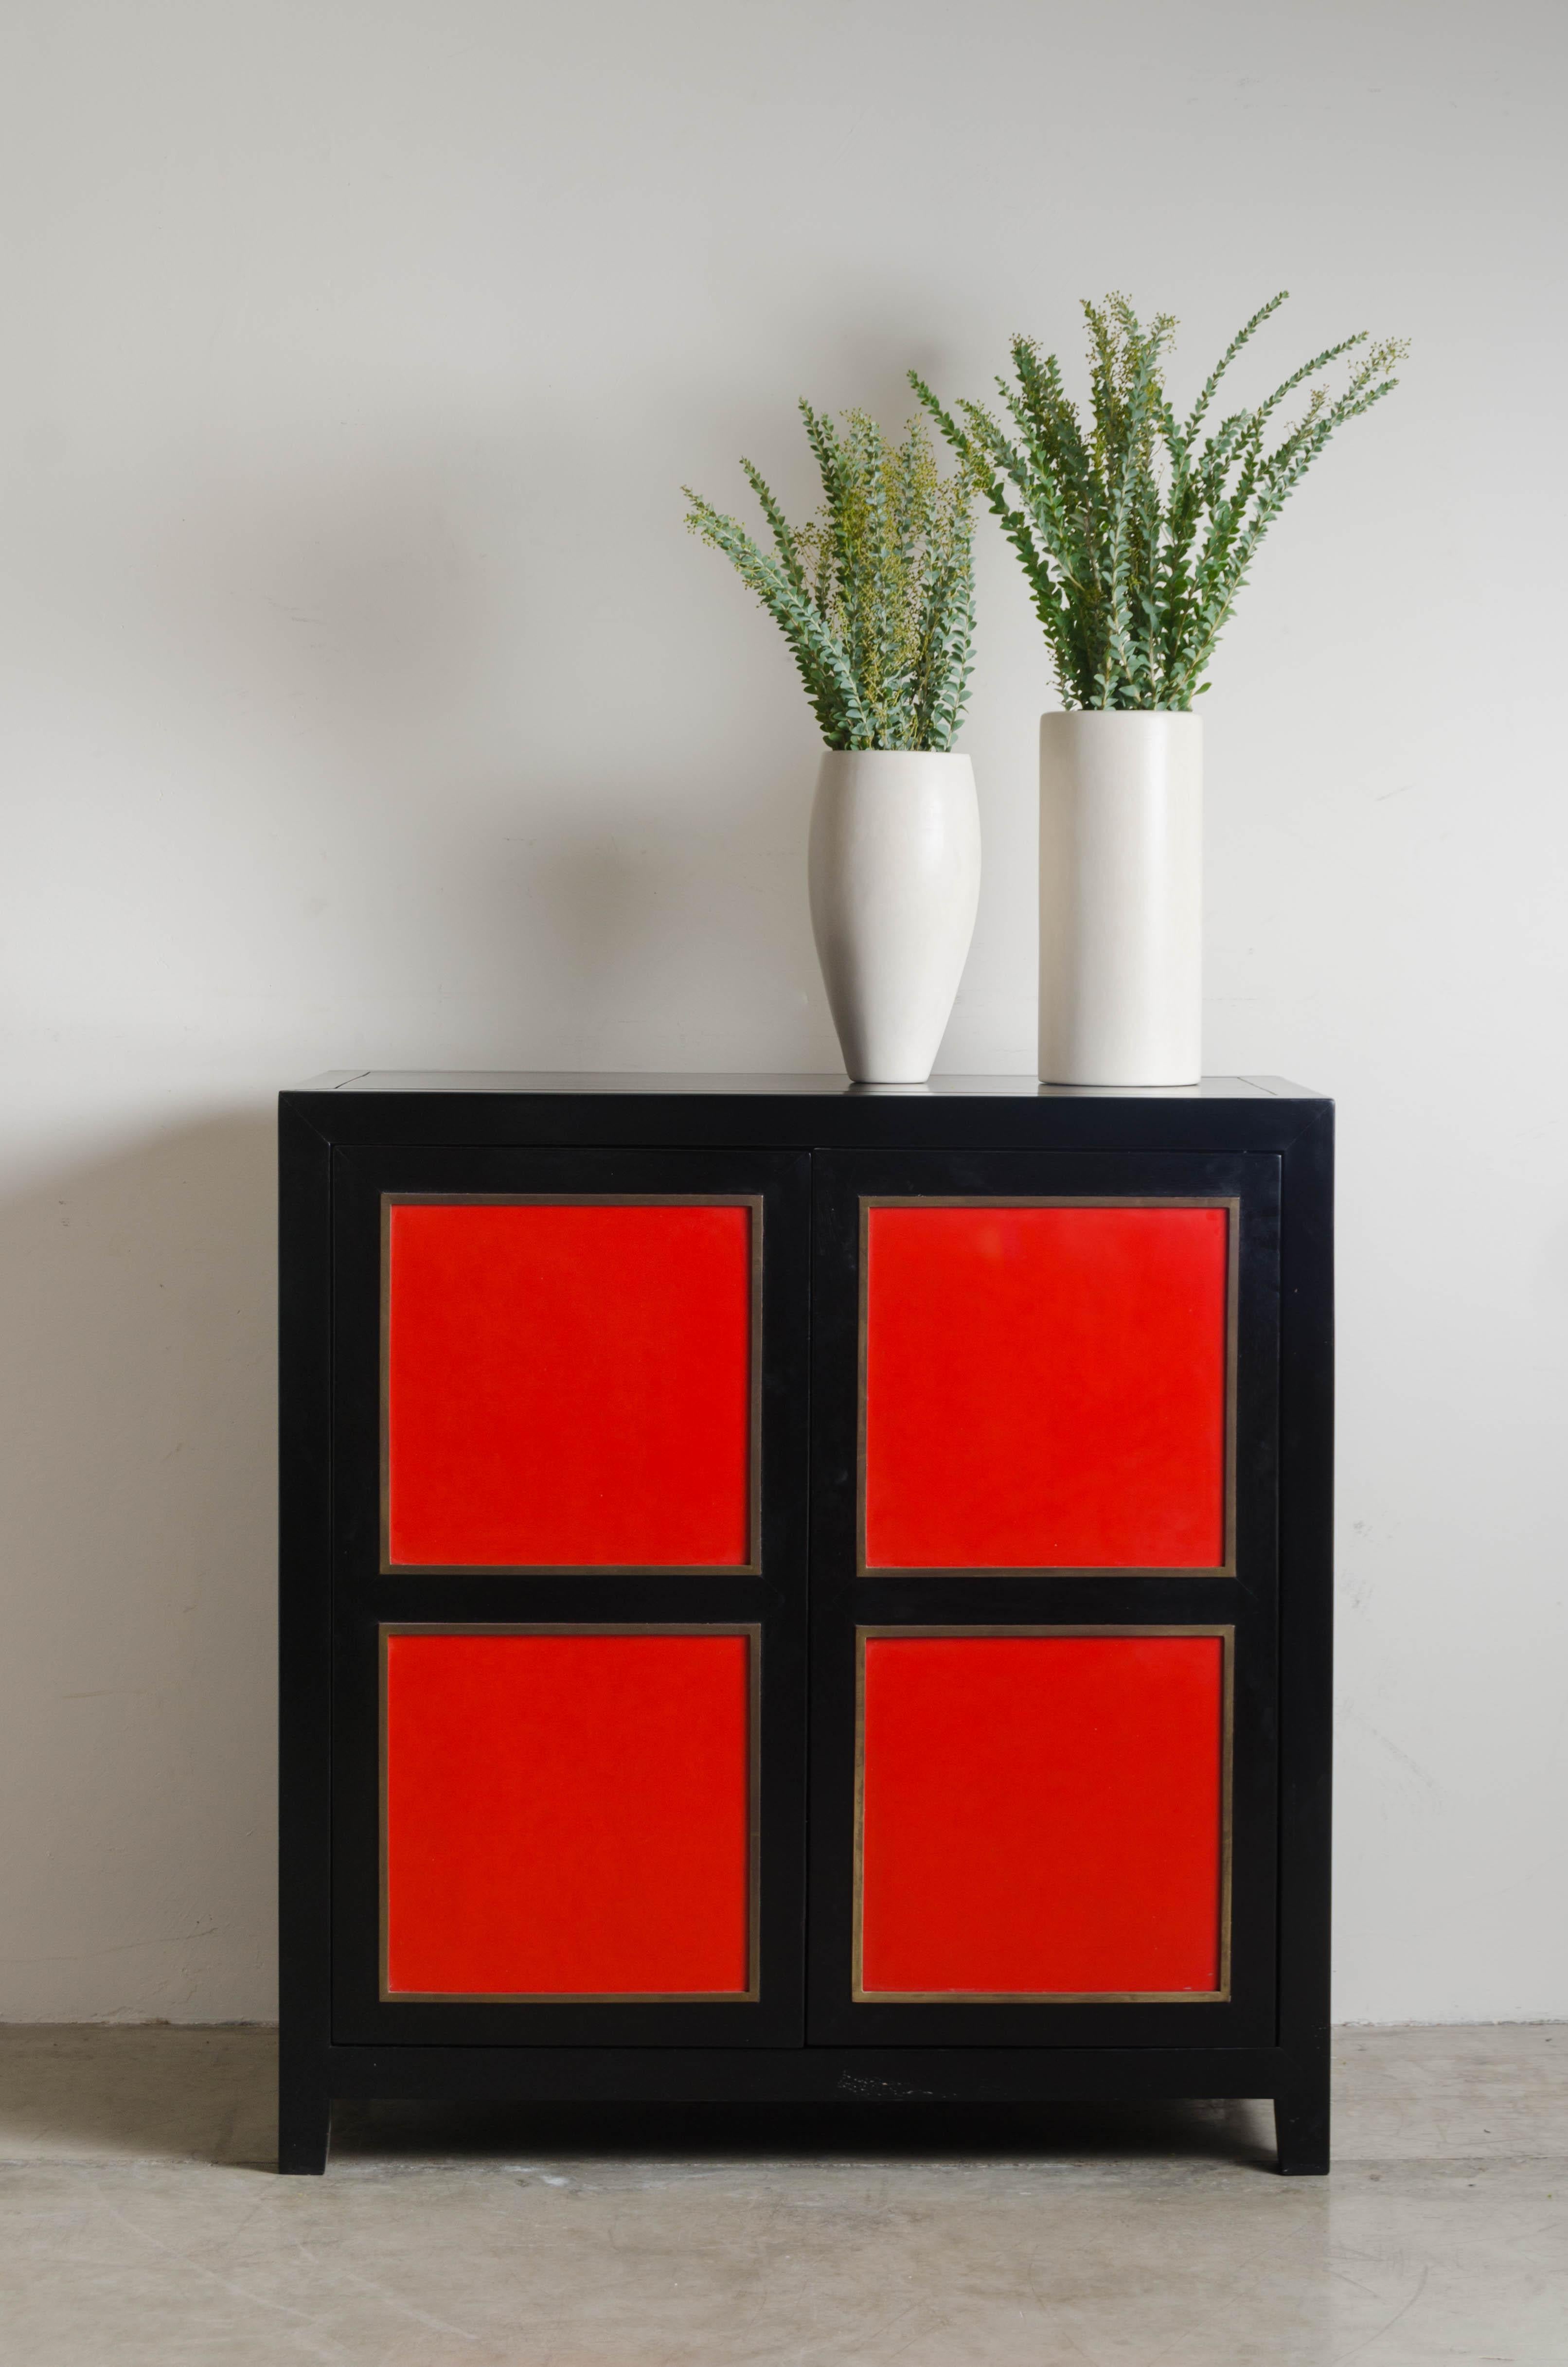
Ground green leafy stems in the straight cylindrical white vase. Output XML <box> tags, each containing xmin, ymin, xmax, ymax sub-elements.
<box><xmin>909</xmin><ymin>294</ymin><xmax>1409</xmax><ymax>708</ymax></box>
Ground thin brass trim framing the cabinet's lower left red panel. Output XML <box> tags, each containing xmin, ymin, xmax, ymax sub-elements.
<box><xmin>376</xmin><ymin>1619</ymin><xmax>763</xmax><ymax>2005</ymax></box>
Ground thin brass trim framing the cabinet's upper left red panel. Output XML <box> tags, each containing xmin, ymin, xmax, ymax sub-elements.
<box><xmin>379</xmin><ymin>1191</ymin><xmax>763</xmax><ymax>1579</ymax></box>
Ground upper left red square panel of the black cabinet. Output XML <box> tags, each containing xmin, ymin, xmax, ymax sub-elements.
<box><xmin>389</xmin><ymin>1202</ymin><xmax>751</xmax><ymax>1567</ymax></box>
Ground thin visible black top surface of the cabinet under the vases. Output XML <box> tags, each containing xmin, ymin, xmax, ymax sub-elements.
<box><xmin>283</xmin><ymin>1068</ymin><xmax>1329</xmax><ymax>1103</ymax></box>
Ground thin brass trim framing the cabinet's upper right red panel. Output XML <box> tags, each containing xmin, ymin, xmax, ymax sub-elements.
<box><xmin>855</xmin><ymin>1193</ymin><xmax>1241</xmax><ymax>1579</ymax></box>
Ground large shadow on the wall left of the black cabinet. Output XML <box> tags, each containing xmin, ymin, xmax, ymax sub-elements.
<box><xmin>0</xmin><ymin>1110</ymin><xmax>277</xmax><ymax>2021</ymax></box>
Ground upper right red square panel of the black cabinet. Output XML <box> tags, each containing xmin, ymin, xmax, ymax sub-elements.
<box><xmin>865</xmin><ymin>1205</ymin><xmax>1227</xmax><ymax>1569</ymax></box>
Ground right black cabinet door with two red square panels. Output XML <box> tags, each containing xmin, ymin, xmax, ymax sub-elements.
<box><xmin>808</xmin><ymin>1153</ymin><xmax>1279</xmax><ymax>2045</ymax></box>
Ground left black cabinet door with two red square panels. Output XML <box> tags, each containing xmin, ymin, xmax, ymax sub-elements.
<box><xmin>332</xmin><ymin>1148</ymin><xmax>808</xmax><ymax>2045</ymax></box>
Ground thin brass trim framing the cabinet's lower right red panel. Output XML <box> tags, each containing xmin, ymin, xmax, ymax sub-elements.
<box><xmin>850</xmin><ymin>1619</ymin><xmax>1236</xmax><ymax>2005</ymax></box>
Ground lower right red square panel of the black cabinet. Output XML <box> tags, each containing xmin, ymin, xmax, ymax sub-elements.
<box><xmin>860</xmin><ymin>1636</ymin><xmax>1225</xmax><ymax>1995</ymax></box>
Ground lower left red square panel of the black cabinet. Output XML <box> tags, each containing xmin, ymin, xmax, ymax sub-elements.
<box><xmin>386</xmin><ymin>1633</ymin><xmax>751</xmax><ymax>1998</ymax></box>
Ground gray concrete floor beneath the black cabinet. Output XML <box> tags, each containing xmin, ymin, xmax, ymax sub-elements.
<box><xmin>0</xmin><ymin>2026</ymin><xmax>1568</xmax><ymax>2367</ymax></box>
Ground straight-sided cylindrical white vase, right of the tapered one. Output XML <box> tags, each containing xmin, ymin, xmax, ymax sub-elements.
<box><xmin>1040</xmin><ymin>710</ymin><xmax>1203</xmax><ymax>1086</ymax></box>
